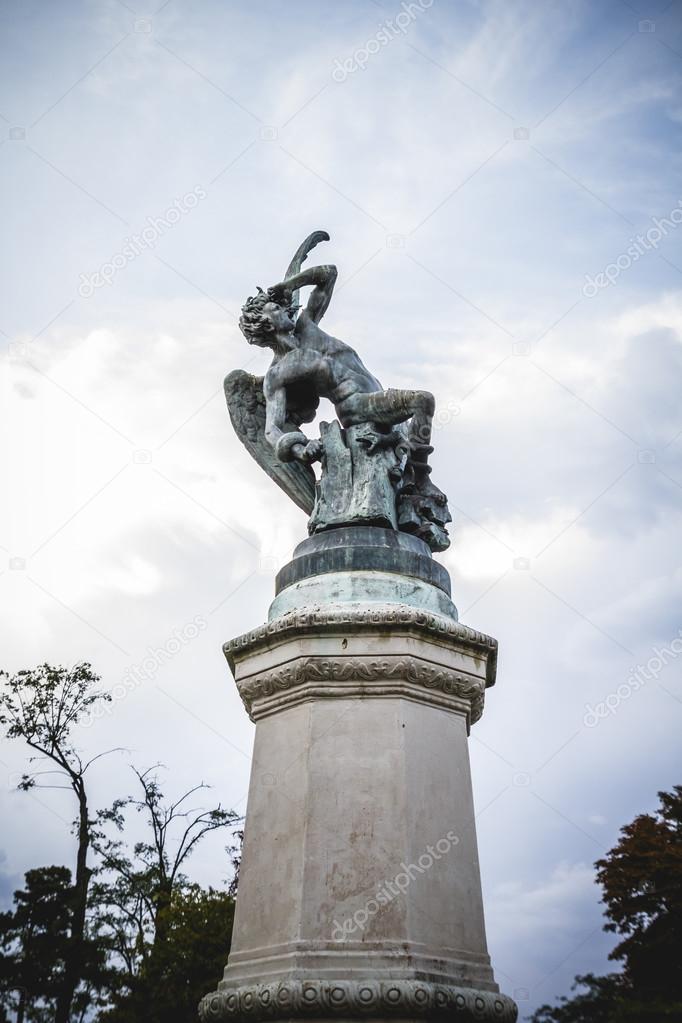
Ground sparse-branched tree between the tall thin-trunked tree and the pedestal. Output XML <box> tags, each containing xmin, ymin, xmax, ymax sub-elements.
<box><xmin>92</xmin><ymin>768</ymin><xmax>239</xmax><ymax>1023</ymax></box>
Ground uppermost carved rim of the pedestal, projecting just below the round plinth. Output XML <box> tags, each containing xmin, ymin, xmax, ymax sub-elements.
<box><xmin>223</xmin><ymin>604</ymin><xmax>497</xmax><ymax>685</ymax></box>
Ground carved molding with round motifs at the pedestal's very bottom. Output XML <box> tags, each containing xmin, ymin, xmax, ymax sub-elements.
<box><xmin>199</xmin><ymin>980</ymin><xmax>518</xmax><ymax>1023</ymax></box>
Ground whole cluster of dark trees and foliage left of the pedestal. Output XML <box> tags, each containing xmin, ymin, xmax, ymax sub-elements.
<box><xmin>0</xmin><ymin>664</ymin><xmax>239</xmax><ymax>1023</ymax></box>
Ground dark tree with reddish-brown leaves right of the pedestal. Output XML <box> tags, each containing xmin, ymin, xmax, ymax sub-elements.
<box><xmin>531</xmin><ymin>786</ymin><xmax>682</xmax><ymax>1023</ymax></box>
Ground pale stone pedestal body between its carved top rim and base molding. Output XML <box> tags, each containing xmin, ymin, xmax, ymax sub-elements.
<box><xmin>215</xmin><ymin>617</ymin><xmax>497</xmax><ymax>990</ymax></box>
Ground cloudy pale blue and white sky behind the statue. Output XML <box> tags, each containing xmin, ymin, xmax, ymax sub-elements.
<box><xmin>0</xmin><ymin>0</ymin><xmax>682</xmax><ymax>1018</ymax></box>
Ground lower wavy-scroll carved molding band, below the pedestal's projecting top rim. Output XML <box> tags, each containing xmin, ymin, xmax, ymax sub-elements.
<box><xmin>237</xmin><ymin>656</ymin><xmax>486</xmax><ymax>724</ymax></box>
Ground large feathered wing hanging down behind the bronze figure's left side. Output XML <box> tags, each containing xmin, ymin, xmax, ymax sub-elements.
<box><xmin>225</xmin><ymin>369</ymin><xmax>315</xmax><ymax>515</ymax></box>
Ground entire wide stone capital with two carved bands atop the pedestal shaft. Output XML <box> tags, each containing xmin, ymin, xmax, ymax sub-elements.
<box><xmin>224</xmin><ymin>604</ymin><xmax>497</xmax><ymax>727</ymax></box>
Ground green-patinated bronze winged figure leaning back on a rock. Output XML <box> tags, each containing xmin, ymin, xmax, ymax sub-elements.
<box><xmin>225</xmin><ymin>231</ymin><xmax>451</xmax><ymax>550</ymax></box>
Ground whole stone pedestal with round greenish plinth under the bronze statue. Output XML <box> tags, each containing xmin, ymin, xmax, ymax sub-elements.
<box><xmin>200</xmin><ymin>528</ymin><xmax>516</xmax><ymax>1023</ymax></box>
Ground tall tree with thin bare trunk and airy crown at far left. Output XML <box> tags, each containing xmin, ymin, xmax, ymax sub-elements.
<box><xmin>0</xmin><ymin>662</ymin><xmax>111</xmax><ymax>1023</ymax></box>
